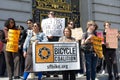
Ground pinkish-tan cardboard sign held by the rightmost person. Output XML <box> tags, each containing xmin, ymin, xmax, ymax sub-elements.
<box><xmin>106</xmin><ymin>29</ymin><xmax>118</xmax><ymax>49</ymax></box>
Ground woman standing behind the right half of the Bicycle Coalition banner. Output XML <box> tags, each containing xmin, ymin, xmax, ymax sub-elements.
<box><xmin>59</xmin><ymin>27</ymin><xmax>76</xmax><ymax>80</ymax></box>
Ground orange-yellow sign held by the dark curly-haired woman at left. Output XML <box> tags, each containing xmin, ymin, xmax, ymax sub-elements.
<box><xmin>6</xmin><ymin>29</ymin><xmax>20</xmax><ymax>52</ymax></box>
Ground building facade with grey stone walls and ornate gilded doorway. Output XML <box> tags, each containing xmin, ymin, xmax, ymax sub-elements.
<box><xmin>0</xmin><ymin>0</ymin><xmax>120</xmax><ymax>71</ymax></box>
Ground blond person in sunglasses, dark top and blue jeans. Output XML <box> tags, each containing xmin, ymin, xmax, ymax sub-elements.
<box><xmin>81</xmin><ymin>21</ymin><xmax>98</xmax><ymax>80</ymax></box>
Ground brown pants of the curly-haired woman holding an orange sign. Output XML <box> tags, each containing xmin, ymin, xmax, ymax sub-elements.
<box><xmin>4</xmin><ymin>44</ymin><xmax>20</xmax><ymax>78</ymax></box>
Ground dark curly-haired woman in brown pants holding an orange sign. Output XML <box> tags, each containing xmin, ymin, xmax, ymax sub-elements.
<box><xmin>3</xmin><ymin>18</ymin><xmax>20</xmax><ymax>80</ymax></box>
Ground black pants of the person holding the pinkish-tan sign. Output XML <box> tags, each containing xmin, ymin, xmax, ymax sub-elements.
<box><xmin>105</xmin><ymin>49</ymin><xmax>118</xmax><ymax>78</ymax></box>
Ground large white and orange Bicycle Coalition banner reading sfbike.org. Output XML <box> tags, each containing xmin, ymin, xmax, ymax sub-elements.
<box><xmin>32</xmin><ymin>42</ymin><xmax>80</xmax><ymax>72</ymax></box>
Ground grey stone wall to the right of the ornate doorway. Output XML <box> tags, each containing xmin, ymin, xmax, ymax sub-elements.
<box><xmin>79</xmin><ymin>0</ymin><xmax>120</xmax><ymax>72</ymax></box>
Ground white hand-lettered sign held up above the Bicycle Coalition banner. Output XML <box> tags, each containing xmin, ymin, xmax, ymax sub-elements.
<box><xmin>41</xmin><ymin>18</ymin><xmax>65</xmax><ymax>36</ymax></box>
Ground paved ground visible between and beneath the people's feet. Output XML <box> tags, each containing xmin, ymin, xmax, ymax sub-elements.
<box><xmin>0</xmin><ymin>74</ymin><xmax>119</xmax><ymax>80</ymax></box>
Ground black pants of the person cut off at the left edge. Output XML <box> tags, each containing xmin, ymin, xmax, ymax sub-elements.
<box><xmin>0</xmin><ymin>52</ymin><xmax>6</xmax><ymax>76</ymax></box>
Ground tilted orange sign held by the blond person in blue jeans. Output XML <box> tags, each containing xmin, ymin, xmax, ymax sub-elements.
<box><xmin>92</xmin><ymin>36</ymin><xmax>103</xmax><ymax>58</ymax></box>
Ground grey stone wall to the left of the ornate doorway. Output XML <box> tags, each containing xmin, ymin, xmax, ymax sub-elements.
<box><xmin>0</xmin><ymin>0</ymin><xmax>32</xmax><ymax>29</ymax></box>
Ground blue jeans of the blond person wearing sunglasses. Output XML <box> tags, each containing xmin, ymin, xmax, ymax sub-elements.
<box><xmin>85</xmin><ymin>51</ymin><xmax>97</xmax><ymax>80</ymax></box>
